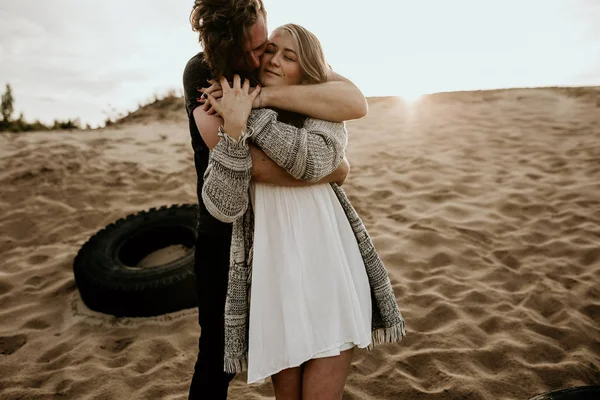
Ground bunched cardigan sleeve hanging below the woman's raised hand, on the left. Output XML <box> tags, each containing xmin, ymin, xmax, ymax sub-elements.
<box><xmin>202</xmin><ymin>129</ymin><xmax>252</xmax><ymax>223</ymax></box>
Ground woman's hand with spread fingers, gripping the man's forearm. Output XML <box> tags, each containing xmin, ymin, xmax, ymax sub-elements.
<box><xmin>203</xmin><ymin>74</ymin><xmax>261</xmax><ymax>139</ymax></box>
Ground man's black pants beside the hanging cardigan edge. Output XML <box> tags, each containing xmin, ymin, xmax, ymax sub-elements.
<box><xmin>188</xmin><ymin>224</ymin><xmax>235</xmax><ymax>400</ymax></box>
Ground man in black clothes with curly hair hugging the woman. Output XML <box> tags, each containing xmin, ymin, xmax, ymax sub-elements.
<box><xmin>183</xmin><ymin>0</ymin><xmax>367</xmax><ymax>400</ymax></box>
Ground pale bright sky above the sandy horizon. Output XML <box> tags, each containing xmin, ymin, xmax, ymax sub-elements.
<box><xmin>0</xmin><ymin>0</ymin><xmax>600</xmax><ymax>126</ymax></box>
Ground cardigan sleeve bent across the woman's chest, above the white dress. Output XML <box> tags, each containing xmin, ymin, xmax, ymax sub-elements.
<box><xmin>248</xmin><ymin>108</ymin><xmax>348</xmax><ymax>182</ymax></box>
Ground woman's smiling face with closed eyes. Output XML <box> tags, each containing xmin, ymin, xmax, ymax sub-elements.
<box><xmin>259</xmin><ymin>31</ymin><xmax>303</xmax><ymax>86</ymax></box>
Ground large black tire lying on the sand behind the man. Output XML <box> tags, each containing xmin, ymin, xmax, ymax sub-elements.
<box><xmin>73</xmin><ymin>204</ymin><xmax>198</xmax><ymax>317</ymax></box>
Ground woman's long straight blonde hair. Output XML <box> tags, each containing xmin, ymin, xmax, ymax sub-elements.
<box><xmin>275</xmin><ymin>24</ymin><xmax>330</xmax><ymax>84</ymax></box>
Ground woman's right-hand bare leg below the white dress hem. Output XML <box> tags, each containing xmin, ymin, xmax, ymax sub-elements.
<box><xmin>302</xmin><ymin>348</ymin><xmax>354</xmax><ymax>400</ymax></box>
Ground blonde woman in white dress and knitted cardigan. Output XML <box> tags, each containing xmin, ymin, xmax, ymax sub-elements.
<box><xmin>202</xmin><ymin>24</ymin><xmax>405</xmax><ymax>399</ymax></box>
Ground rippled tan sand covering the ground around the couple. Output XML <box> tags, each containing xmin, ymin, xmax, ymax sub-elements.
<box><xmin>0</xmin><ymin>88</ymin><xmax>600</xmax><ymax>400</ymax></box>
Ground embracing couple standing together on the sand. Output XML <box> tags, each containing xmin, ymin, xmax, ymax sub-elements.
<box><xmin>183</xmin><ymin>0</ymin><xmax>405</xmax><ymax>400</ymax></box>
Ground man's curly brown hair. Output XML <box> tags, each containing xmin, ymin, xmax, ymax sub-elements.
<box><xmin>190</xmin><ymin>0</ymin><xmax>267</xmax><ymax>80</ymax></box>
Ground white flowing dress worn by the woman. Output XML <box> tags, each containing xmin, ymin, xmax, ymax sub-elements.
<box><xmin>248</xmin><ymin>183</ymin><xmax>372</xmax><ymax>383</ymax></box>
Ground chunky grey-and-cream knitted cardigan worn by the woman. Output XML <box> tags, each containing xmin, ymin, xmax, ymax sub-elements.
<box><xmin>202</xmin><ymin>108</ymin><xmax>406</xmax><ymax>373</ymax></box>
